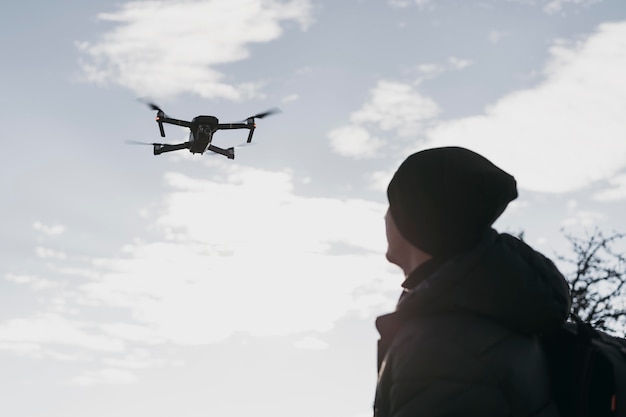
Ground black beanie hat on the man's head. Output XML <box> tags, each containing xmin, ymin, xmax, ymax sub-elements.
<box><xmin>387</xmin><ymin>147</ymin><xmax>517</xmax><ymax>257</ymax></box>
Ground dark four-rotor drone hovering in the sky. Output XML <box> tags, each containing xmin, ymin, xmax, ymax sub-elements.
<box><xmin>128</xmin><ymin>103</ymin><xmax>280</xmax><ymax>159</ymax></box>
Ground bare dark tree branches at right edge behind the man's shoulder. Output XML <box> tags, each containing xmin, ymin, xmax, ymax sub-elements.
<box><xmin>557</xmin><ymin>229</ymin><xmax>626</xmax><ymax>336</ymax></box>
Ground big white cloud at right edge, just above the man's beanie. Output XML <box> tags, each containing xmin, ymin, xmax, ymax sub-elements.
<box><xmin>427</xmin><ymin>22</ymin><xmax>626</xmax><ymax>192</ymax></box>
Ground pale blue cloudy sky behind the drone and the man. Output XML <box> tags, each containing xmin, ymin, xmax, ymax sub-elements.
<box><xmin>0</xmin><ymin>0</ymin><xmax>626</xmax><ymax>417</ymax></box>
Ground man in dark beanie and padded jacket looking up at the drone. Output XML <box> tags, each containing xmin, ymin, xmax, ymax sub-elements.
<box><xmin>374</xmin><ymin>147</ymin><xmax>570</xmax><ymax>417</ymax></box>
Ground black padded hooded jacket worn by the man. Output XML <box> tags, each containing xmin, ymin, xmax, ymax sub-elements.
<box><xmin>374</xmin><ymin>230</ymin><xmax>570</xmax><ymax>417</ymax></box>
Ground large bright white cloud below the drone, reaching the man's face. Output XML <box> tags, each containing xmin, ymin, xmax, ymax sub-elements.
<box><xmin>75</xmin><ymin>166</ymin><xmax>394</xmax><ymax>344</ymax></box>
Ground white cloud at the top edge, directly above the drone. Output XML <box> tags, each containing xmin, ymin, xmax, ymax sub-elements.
<box><xmin>77</xmin><ymin>0</ymin><xmax>312</xmax><ymax>100</ymax></box>
